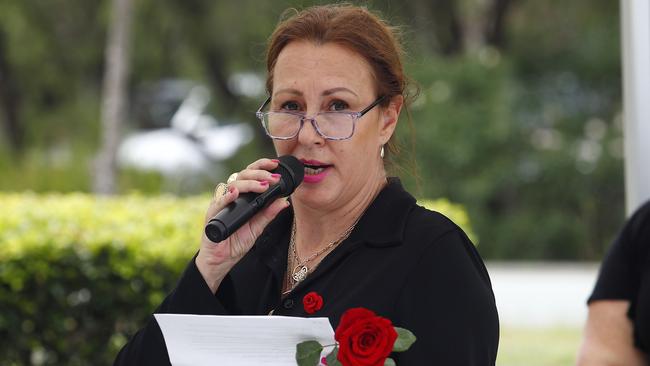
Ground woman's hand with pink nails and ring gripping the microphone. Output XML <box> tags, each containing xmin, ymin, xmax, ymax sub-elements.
<box><xmin>196</xmin><ymin>159</ymin><xmax>289</xmax><ymax>293</ymax></box>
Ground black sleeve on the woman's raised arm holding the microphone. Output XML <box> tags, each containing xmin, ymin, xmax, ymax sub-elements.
<box><xmin>114</xmin><ymin>257</ymin><xmax>234</xmax><ymax>366</ymax></box>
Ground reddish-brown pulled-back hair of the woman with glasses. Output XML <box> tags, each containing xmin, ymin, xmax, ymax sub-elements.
<box><xmin>266</xmin><ymin>4</ymin><xmax>410</xmax><ymax>163</ymax></box>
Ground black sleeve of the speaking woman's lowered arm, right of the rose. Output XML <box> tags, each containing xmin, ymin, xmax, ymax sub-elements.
<box><xmin>394</xmin><ymin>230</ymin><xmax>499</xmax><ymax>366</ymax></box>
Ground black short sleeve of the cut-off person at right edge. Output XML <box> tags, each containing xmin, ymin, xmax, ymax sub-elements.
<box><xmin>587</xmin><ymin>202</ymin><xmax>650</xmax><ymax>303</ymax></box>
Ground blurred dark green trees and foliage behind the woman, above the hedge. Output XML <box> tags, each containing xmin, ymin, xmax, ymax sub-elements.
<box><xmin>0</xmin><ymin>0</ymin><xmax>624</xmax><ymax>260</ymax></box>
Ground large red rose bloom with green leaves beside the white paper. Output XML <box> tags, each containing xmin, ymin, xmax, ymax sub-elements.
<box><xmin>334</xmin><ymin>308</ymin><xmax>397</xmax><ymax>366</ymax></box>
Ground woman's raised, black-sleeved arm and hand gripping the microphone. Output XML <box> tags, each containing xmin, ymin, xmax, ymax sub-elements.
<box><xmin>114</xmin><ymin>159</ymin><xmax>289</xmax><ymax>366</ymax></box>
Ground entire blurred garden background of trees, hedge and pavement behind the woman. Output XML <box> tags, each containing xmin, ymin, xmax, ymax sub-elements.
<box><xmin>0</xmin><ymin>0</ymin><xmax>625</xmax><ymax>365</ymax></box>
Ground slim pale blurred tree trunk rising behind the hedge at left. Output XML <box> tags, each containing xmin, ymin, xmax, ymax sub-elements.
<box><xmin>93</xmin><ymin>0</ymin><xmax>133</xmax><ymax>195</ymax></box>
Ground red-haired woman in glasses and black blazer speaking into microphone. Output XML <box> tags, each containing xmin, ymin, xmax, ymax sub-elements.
<box><xmin>116</xmin><ymin>5</ymin><xmax>499</xmax><ymax>365</ymax></box>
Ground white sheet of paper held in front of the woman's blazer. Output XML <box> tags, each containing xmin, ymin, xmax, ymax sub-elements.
<box><xmin>154</xmin><ymin>314</ymin><xmax>334</xmax><ymax>366</ymax></box>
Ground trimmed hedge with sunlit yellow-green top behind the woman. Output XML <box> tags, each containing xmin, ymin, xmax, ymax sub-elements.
<box><xmin>0</xmin><ymin>193</ymin><xmax>467</xmax><ymax>365</ymax></box>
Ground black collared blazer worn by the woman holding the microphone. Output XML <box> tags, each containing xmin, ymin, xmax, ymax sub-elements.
<box><xmin>115</xmin><ymin>178</ymin><xmax>499</xmax><ymax>366</ymax></box>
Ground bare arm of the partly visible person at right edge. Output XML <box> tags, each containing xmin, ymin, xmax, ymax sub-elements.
<box><xmin>577</xmin><ymin>300</ymin><xmax>648</xmax><ymax>366</ymax></box>
